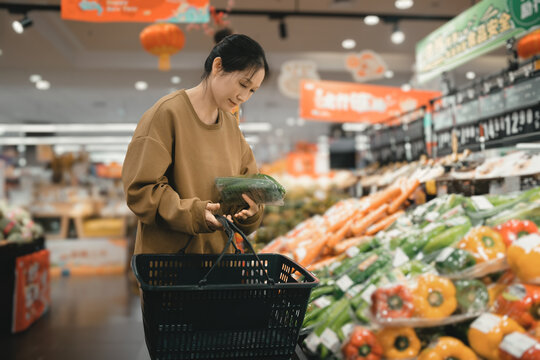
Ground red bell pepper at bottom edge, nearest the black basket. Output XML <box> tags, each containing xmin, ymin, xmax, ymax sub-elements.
<box><xmin>343</xmin><ymin>326</ymin><xmax>383</xmax><ymax>360</ymax></box>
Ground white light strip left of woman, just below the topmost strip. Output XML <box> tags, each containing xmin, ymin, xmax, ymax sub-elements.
<box><xmin>0</xmin><ymin>136</ymin><xmax>131</xmax><ymax>145</ymax></box>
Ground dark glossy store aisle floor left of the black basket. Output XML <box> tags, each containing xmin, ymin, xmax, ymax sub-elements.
<box><xmin>0</xmin><ymin>275</ymin><xmax>150</xmax><ymax>360</ymax></box>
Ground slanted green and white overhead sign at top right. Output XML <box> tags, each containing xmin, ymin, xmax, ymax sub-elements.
<box><xmin>416</xmin><ymin>0</ymin><xmax>540</xmax><ymax>82</ymax></box>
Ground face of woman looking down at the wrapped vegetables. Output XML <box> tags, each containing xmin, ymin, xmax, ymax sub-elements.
<box><xmin>211</xmin><ymin>58</ymin><xmax>264</xmax><ymax>112</ymax></box>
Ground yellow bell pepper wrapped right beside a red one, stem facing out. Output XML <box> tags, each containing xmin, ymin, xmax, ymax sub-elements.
<box><xmin>413</xmin><ymin>274</ymin><xmax>457</xmax><ymax>319</ymax></box>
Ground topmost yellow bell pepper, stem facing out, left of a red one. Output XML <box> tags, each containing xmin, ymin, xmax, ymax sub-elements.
<box><xmin>458</xmin><ymin>226</ymin><xmax>506</xmax><ymax>263</ymax></box>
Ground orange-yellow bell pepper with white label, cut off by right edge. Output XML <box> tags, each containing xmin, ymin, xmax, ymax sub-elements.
<box><xmin>507</xmin><ymin>235</ymin><xmax>540</xmax><ymax>282</ymax></box>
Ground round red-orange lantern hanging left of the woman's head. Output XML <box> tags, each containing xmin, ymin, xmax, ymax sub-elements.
<box><xmin>139</xmin><ymin>23</ymin><xmax>186</xmax><ymax>71</ymax></box>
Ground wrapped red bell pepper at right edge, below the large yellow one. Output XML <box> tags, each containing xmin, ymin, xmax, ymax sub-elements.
<box><xmin>494</xmin><ymin>284</ymin><xmax>540</xmax><ymax>329</ymax></box>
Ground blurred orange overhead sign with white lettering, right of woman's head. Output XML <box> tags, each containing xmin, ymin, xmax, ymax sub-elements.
<box><xmin>300</xmin><ymin>80</ymin><xmax>441</xmax><ymax>123</ymax></box>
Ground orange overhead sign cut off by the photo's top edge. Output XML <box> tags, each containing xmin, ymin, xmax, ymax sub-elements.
<box><xmin>61</xmin><ymin>0</ymin><xmax>210</xmax><ymax>23</ymax></box>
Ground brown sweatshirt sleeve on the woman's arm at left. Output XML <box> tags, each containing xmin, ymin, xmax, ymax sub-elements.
<box><xmin>122</xmin><ymin>136</ymin><xmax>212</xmax><ymax>235</ymax></box>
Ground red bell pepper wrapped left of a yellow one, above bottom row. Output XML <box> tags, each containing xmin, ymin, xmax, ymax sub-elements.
<box><xmin>371</xmin><ymin>285</ymin><xmax>414</xmax><ymax>319</ymax></box>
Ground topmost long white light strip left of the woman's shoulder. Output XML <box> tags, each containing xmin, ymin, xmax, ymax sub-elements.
<box><xmin>0</xmin><ymin>124</ymin><xmax>137</xmax><ymax>133</ymax></box>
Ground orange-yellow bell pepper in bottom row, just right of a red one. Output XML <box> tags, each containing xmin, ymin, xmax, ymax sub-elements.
<box><xmin>377</xmin><ymin>327</ymin><xmax>421</xmax><ymax>359</ymax></box>
